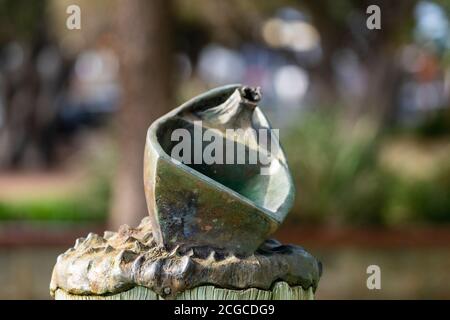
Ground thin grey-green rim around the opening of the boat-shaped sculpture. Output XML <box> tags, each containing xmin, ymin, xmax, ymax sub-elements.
<box><xmin>144</xmin><ymin>84</ymin><xmax>295</xmax><ymax>225</ymax></box>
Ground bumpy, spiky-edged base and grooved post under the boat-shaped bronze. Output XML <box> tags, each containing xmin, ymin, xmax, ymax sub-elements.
<box><xmin>50</xmin><ymin>218</ymin><xmax>321</xmax><ymax>300</ymax></box>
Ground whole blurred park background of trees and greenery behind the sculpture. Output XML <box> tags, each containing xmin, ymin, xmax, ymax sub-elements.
<box><xmin>0</xmin><ymin>0</ymin><xmax>450</xmax><ymax>299</ymax></box>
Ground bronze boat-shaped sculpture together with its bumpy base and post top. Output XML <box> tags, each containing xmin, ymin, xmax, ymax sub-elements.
<box><xmin>50</xmin><ymin>85</ymin><xmax>321</xmax><ymax>299</ymax></box>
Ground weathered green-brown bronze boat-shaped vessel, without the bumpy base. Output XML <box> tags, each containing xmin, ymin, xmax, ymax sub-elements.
<box><xmin>144</xmin><ymin>85</ymin><xmax>295</xmax><ymax>254</ymax></box>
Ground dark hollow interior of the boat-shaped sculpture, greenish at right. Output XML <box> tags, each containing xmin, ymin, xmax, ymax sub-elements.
<box><xmin>157</xmin><ymin>116</ymin><xmax>290</xmax><ymax>218</ymax></box>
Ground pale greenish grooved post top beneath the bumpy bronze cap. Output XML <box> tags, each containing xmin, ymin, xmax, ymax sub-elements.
<box><xmin>55</xmin><ymin>281</ymin><xmax>314</xmax><ymax>300</ymax></box>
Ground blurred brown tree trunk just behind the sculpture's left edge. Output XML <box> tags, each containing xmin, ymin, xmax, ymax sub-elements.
<box><xmin>109</xmin><ymin>0</ymin><xmax>172</xmax><ymax>228</ymax></box>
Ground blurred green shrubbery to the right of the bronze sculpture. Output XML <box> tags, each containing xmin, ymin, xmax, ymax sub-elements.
<box><xmin>282</xmin><ymin>112</ymin><xmax>450</xmax><ymax>225</ymax></box>
